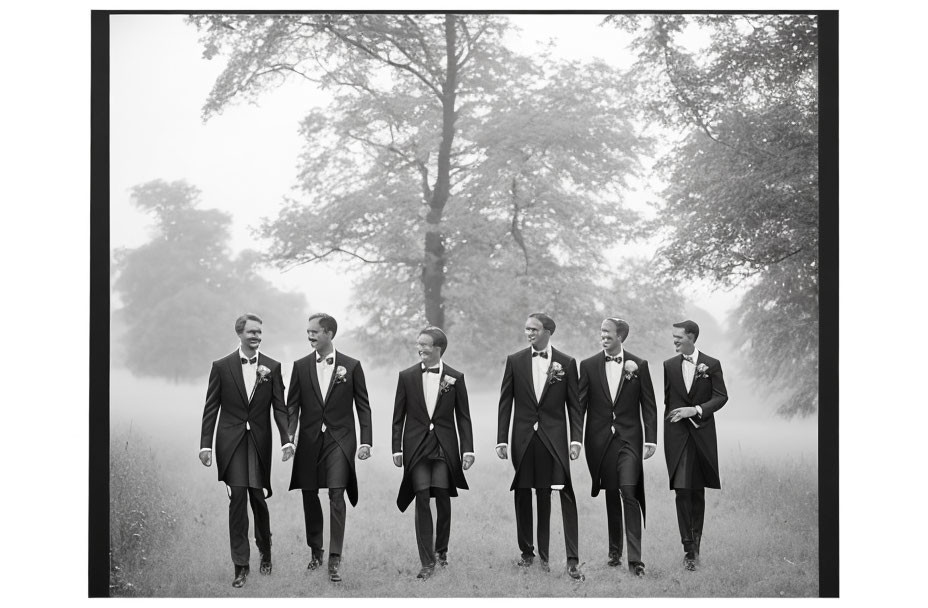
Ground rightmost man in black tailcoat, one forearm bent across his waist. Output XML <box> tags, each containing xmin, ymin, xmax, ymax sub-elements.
<box><xmin>664</xmin><ymin>321</ymin><xmax>728</xmax><ymax>570</ymax></box>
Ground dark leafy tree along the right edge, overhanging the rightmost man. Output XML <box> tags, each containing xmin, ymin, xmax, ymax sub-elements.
<box><xmin>611</xmin><ymin>15</ymin><xmax>819</xmax><ymax>417</ymax></box>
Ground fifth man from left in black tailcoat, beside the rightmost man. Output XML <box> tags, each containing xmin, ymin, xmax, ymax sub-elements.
<box><xmin>580</xmin><ymin>318</ymin><xmax>657</xmax><ymax>576</ymax></box>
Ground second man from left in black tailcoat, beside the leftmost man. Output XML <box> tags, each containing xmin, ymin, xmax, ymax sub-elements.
<box><xmin>287</xmin><ymin>313</ymin><xmax>373</xmax><ymax>583</ymax></box>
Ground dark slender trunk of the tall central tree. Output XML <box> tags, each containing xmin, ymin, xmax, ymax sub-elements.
<box><xmin>422</xmin><ymin>15</ymin><xmax>458</xmax><ymax>329</ymax></box>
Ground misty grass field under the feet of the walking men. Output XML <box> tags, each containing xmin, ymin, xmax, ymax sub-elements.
<box><xmin>111</xmin><ymin>368</ymin><xmax>818</xmax><ymax>597</ymax></box>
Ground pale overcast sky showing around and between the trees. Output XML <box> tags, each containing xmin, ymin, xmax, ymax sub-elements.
<box><xmin>110</xmin><ymin>15</ymin><xmax>739</xmax><ymax>326</ymax></box>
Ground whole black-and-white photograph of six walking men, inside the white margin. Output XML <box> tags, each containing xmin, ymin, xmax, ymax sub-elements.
<box><xmin>92</xmin><ymin>11</ymin><xmax>837</xmax><ymax>598</ymax></box>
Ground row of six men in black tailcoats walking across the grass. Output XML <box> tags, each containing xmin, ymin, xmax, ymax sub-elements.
<box><xmin>200</xmin><ymin>313</ymin><xmax>728</xmax><ymax>587</ymax></box>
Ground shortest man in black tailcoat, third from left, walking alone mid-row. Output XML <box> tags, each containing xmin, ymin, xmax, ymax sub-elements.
<box><xmin>393</xmin><ymin>327</ymin><xmax>474</xmax><ymax>579</ymax></box>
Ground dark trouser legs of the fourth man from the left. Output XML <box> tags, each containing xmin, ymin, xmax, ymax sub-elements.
<box><xmin>515</xmin><ymin>488</ymin><xmax>579</xmax><ymax>565</ymax></box>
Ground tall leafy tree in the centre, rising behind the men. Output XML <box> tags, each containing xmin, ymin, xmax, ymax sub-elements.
<box><xmin>191</xmin><ymin>14</ymin><xmax>649</xmax><ymax>376</ymax></box>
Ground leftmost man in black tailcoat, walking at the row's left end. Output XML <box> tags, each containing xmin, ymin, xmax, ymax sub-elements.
<box><xmin>200</xmin><ymin>314</ymin><xmax>293</xmax><ymax>588</ymax></box>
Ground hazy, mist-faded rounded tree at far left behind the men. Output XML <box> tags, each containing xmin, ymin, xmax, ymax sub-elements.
<box><xmin>113</xmin><ymin>180</ymin><xmax>306</xmax><ymax>382</ymax></box>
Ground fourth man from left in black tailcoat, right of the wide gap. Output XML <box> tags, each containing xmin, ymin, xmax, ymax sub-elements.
<box><xmin>496</xmin><ymin>313</ymin><xmax>584</xmax><ymax>581</ymax></box>
